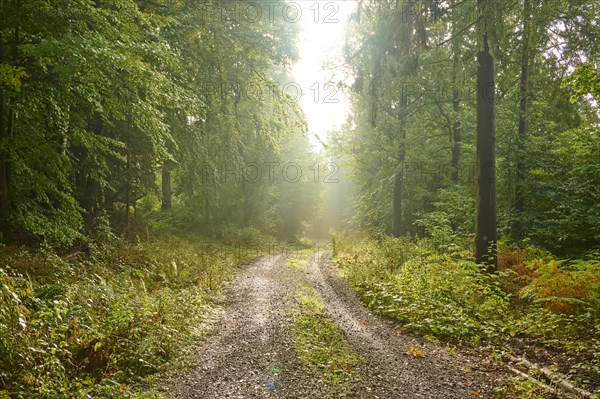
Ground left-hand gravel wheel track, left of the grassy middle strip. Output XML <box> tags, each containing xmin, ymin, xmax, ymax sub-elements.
<box><xmin>171</xmin><ymin>255</ymin><xmax>324</xmax><ymax>399</ymax></box>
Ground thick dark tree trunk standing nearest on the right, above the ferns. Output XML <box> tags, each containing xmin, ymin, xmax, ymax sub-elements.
<box><xmin>475</xmin><ymin>7</ymin><xmax>498</xmax><ymax>272</ymax></box>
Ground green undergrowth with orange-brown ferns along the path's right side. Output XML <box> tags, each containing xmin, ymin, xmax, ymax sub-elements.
<box><xmin>333</xmin><ymin>232</ymin><xmax>600</xmax><ymax>397</ymax></box>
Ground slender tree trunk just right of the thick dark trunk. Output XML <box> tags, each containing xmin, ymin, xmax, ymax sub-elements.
<box><xmin>512</xmin><ymin>0</ymin><xmax>531</xmax><ymax>239</ymax></box>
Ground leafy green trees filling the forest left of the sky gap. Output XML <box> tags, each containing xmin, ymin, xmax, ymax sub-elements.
<box><xmin>0</xmin><ymin>0</ymin><xmax>316</xmax><ymax>247</ymax></box>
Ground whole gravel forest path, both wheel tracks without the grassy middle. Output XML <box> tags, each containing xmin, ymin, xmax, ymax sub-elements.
<box><xmin>172</xmin><ymin>252</ymin><xmax>498</xmax><ymax>399</ymax></box>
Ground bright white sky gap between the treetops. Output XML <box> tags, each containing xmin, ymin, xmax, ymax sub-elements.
<box><xmin>290</xmin><ymin>0</ymin><xmax>356</xmax><ymax>148</ymax></box>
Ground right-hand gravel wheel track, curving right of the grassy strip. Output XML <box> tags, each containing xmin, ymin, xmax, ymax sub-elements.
<box><xmin>308</xmin><ymin>252</ymin><xmax>494</xmax><ymax>399</ymax></box>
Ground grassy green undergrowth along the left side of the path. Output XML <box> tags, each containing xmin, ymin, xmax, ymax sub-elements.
<box><xmin>0</xmin><ymin>236</ymin><xmax>264</xmax><ymax>399</ymax></box>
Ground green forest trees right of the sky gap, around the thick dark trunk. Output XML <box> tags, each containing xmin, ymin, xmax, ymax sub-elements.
<box><xmin>329</xmin><ymin>0</ymin><xmax>600</xmax><ymax>258</ymax></box>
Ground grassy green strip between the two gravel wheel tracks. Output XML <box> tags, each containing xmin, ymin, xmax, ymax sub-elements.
<box><xmin>291</xmin><ymin>285</ymin><xmax>363</xmax><ymax>397</ymax></box>
